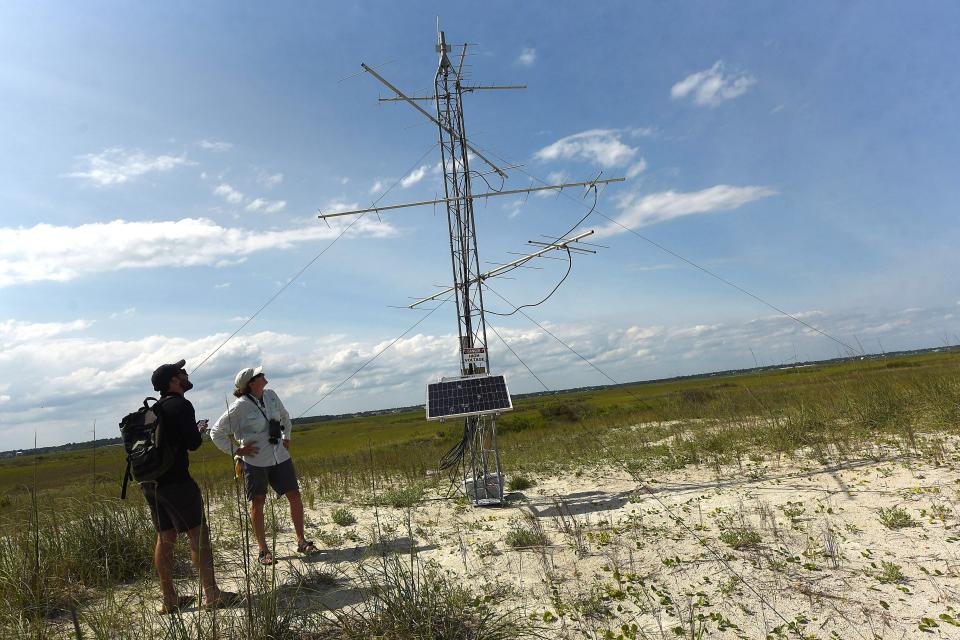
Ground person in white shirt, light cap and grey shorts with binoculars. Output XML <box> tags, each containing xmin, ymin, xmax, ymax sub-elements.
<box><xmin>210</xmin><ymin>367</ymin><xmax>318</xmax><ymax>566</ymax></box>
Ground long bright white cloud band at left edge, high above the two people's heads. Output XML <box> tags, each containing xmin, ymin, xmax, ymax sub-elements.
<box><xmin>0</xmin><ymin>218</ymin><xmax>395</xmax><ymax>287</ymax></box>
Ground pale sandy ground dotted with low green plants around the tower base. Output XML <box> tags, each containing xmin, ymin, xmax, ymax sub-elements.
<box><xmin>77</xmin><ymin>440</ymin><xmax>960</xmax><ymax>638</ymax></box>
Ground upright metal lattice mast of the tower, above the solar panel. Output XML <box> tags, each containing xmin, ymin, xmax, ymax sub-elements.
<box><xmin>434</xmin><ymin>31</ymin><xmax>490</xmax><ymax>375</ymax></box>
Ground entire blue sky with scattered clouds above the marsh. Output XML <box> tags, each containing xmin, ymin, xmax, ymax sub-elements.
<box><xmin>0</xmin><ymin>2</ymin><xmax>960</xmax><ymax>448</ymax></box>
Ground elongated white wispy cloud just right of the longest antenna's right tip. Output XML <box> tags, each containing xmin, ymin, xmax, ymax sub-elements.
<box><xmin>597</xmin><ymin>184</ymin><xmax>777</xmax><ymax>237</ymax></box>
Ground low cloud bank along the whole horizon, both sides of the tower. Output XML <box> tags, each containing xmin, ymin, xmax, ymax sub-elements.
<box><xmin>0</xmin><ymin>304</ymin><xmax>952</xmax><ymax>448</ymax></box>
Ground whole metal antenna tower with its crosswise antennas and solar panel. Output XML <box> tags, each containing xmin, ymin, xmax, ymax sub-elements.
<box><xmin>318</xmin><ymin>23</ymin><xmax>624</xmax><ymax>505</ymax></box>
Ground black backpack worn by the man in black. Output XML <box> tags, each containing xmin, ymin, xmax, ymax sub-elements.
<box><xmin>120</xmin><ymin>398</ymin><xmax>174</xmax><ymax>499</ymax></box>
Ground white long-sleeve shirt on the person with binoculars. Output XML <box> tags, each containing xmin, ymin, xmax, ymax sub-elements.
<box><xmin>210</xmin><ymin>389</ymin><xmax>293</xmax><ymax>467</ymax></box>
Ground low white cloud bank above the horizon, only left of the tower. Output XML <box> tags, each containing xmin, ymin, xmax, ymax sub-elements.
<box><xmin>0</xmin><ymin>321</ymin><xmax>456</xmax><ymax>448</ymax></box>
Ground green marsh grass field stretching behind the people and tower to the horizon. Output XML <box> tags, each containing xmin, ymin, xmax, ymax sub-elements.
<box><xmin>0</xmin><ymin>351</ymin><xmax>960</xmax><ymax>638</ymax></box>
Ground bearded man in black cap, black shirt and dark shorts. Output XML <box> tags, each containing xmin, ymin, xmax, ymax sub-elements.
<box><xmin>140</xmin><ymin>360</ymin><xmax>240</xmax><ymax>614</ymax></box>
